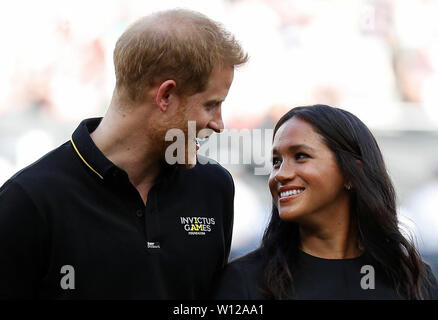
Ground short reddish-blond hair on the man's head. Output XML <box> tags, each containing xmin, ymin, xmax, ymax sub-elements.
<box><xmin>114</xmin><ymin>9</ymin><xmax>248</xmax><ymax>102</ymax></box>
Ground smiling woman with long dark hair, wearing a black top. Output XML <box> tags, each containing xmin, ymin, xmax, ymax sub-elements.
<box><xmin>217</xmin><ymin>105</ymin><xmax>438</xmax><ymax>300</ymax></box>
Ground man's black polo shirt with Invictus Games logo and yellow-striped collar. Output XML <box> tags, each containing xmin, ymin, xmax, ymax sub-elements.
<box><xmin>0</xmin><ymin>118</ymin><xmax>234</xmax><ymax>299</ymax></box>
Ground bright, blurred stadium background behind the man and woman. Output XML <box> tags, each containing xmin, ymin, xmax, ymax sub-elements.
<box><xmin>0</xmin><ymin>0</ymin><xmax>438</xmax><ymax>271</ymax></box>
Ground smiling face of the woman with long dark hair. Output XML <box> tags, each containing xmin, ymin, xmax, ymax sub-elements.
<box><xmin>269</xmin><ymin>117</ymin><xmax>349</xmax><ymax>223</ymax></box>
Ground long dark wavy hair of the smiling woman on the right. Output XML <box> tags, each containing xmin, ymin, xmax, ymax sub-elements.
<box><xmin>261</xmin><ymin>105</ymin><xmax>427</xmax><ymax>299</ymax></box>
